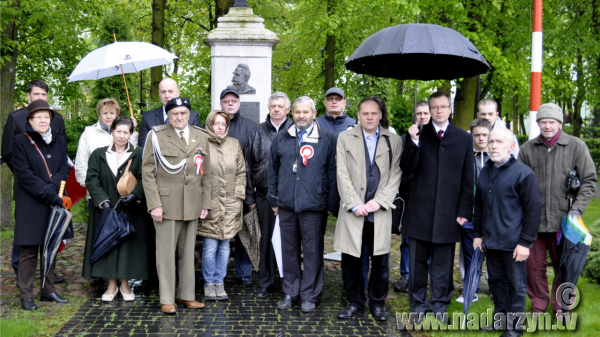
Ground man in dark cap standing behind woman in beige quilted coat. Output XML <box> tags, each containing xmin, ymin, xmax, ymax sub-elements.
<box><xmin>221</xmin><ymin>87</ymin><xmax>256</xmax><ymax>285</ymax></box>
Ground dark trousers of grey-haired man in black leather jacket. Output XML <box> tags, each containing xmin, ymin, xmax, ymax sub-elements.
<box><xmin>256</xmin><ymin>194</ymin><xmax>277</xmax><ymax>288</ymax></box>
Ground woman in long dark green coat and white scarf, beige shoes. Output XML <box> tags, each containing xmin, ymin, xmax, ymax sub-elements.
<box><xmin>83</xmin><ymin>117</ymin><xmax>152</xmax><ymax>302</ymax></box>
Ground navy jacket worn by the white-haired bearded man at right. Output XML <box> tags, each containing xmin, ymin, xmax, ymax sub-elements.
<box><xmin>473</xmin><ymin>156</ymin><xmax>542</xmax><ymax>252</ymax></box>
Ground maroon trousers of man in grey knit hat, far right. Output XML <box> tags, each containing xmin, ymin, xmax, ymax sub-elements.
<box><xmin>528</xmin><ymin>233</ymin><xmax>560</xmax><ymax>312</ymax></box>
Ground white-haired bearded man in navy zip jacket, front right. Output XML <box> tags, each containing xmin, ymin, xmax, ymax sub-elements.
<box><xmin>473</xmin><ymin>128</ymin><xmax>542</xmax><ymax>337</ymax></box>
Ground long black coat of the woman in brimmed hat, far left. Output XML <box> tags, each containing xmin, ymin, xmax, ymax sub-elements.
<box><xmin>12</xmin><ymin>123</ymin><xmax>73</xmax><ymax>246</ymax></box>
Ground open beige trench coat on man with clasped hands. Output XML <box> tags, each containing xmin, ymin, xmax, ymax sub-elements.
<box><xmin>333</xmin><ymin>126</ymin><xmax>402</xmax><ymax>257</ymax></box>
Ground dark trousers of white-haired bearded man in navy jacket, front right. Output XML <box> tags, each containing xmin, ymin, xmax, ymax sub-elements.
<box><xmin>485</xmin><ymin>249</ymin><xmax>527</xmax><ymax>328</ymax></box>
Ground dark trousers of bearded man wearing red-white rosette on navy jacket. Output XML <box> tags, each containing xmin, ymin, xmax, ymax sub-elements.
<box><xmin>279</xmin><ymin>208</ymin><xmax>327</xmax><ymax>303</ymax></box>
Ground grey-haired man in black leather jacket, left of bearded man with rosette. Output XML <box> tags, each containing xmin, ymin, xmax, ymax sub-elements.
<box><xmin>244</xmin><ymin>92</ymin><xmax>293</xmax><ymax>298</ymax></box>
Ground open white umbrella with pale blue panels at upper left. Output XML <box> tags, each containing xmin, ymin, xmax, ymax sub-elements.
<box><xmin>69</xmin><ymin>37</ymin><xmax>177</xmax><ymax>117</ymax></box>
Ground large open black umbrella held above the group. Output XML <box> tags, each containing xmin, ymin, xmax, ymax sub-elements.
<box><xmin>346</xmin><ymin>23</ymin><xmax>491</xmax><ymax>122</ymax></box>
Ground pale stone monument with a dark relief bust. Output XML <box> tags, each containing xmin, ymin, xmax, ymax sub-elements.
<box><xmin>204</xmin><ymin>0</ymin><xmax>279</xmax><ymax>123</ymax></box>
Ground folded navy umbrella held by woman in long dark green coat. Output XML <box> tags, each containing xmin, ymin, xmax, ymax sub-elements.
<box><xmin>91</xmin><ymin>202</ymin><xmax>135</xmax><ymax>263</ymax></box>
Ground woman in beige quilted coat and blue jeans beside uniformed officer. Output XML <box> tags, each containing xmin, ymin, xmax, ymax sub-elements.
<box><xmin>198</xmin><ymin>111</ymin><xmax>246</xmax><ymax>301</ymax></box>
